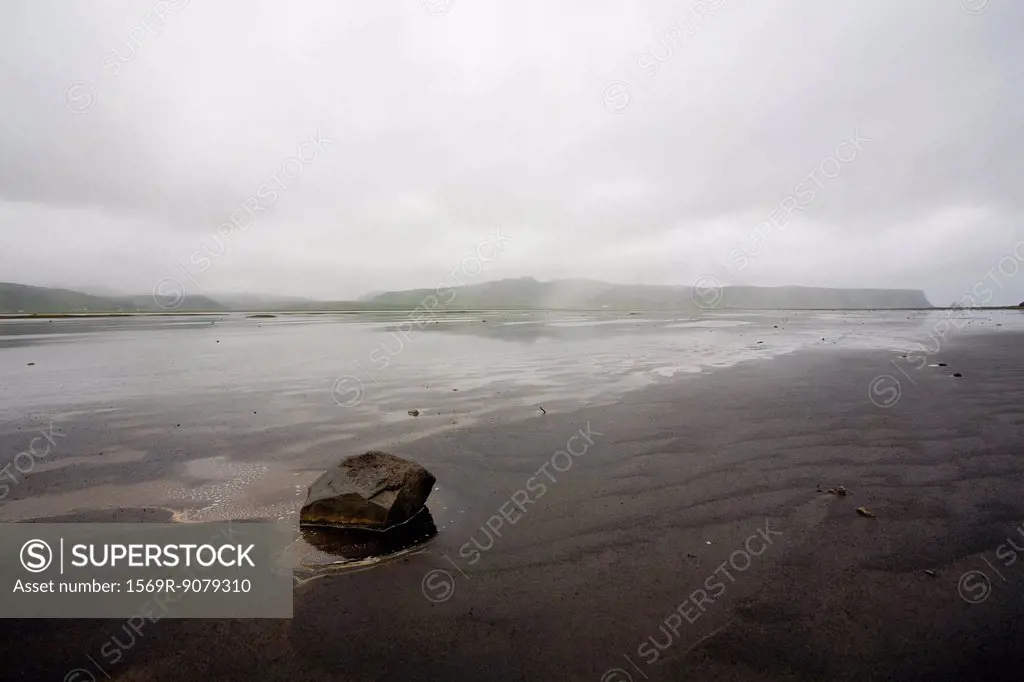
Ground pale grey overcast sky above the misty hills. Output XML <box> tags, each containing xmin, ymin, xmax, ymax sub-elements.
<box><xmin>0</xmin><ymin>0</ymin><xmax>1024</xmax><ymax>304</ymax></box>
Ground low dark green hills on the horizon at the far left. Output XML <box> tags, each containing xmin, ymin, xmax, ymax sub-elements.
<box><xmin>0</xmin><ymin>283</ymin><xmax>226</xmax><ymax>314</ymax></box>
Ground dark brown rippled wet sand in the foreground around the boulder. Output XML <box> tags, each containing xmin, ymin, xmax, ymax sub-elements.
<box><xmin>0</xmin><ymin>332</ymin><xmax>1024</xmax><ymax>682</ymax></box>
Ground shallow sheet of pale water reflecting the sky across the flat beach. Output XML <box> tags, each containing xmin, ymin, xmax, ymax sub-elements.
<box><xmin>0</xmin><ymin>311</ymin><xmax>1024</xmax><ymax>520</ymax></box>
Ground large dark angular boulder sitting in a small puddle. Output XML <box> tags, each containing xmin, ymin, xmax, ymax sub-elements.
<box><xmin>299</xmin><ymin>451</ymin><xmax>435</xmax><ymax>530</ymax></box>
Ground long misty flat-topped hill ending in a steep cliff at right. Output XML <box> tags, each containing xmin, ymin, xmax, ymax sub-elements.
<box><xmin>368</xmin><ymin>278</ymin><xmax>932</xmax><ymax>310</ymax></box>
